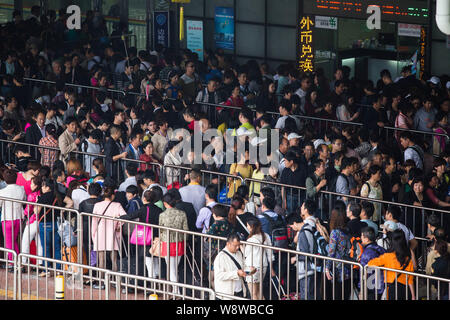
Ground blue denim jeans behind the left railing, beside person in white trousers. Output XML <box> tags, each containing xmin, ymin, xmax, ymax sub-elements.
<box><xmin>39</xmin><ymin>222</ymin><xmax>61</xmax><ymax>269</ymax></box>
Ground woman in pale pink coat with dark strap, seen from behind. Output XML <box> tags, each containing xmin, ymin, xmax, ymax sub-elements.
<box><xmin>91</xmin><ymin>186</ymin><xmax>127</xmax><ymax>271</ymax></box>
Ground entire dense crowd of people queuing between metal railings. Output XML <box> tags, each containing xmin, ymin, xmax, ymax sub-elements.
<box><xmin>0</xmin><ymin>7</ymin><xmax>450</xmax><ymax>299</ymax></box>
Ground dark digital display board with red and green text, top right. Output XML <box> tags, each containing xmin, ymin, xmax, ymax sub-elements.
<box><xmin>303</xmin><ymin>0</ymin><xmax>428</xmax><ymax>24</ymax></box>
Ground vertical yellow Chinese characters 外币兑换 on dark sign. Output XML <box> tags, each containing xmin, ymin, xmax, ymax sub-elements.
<box><xmin>298</xmin><ymin>17</ymin><xmax>314</xmax><ymax>72</ymax></box>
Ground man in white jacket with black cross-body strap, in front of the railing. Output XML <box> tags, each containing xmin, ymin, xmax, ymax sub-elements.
<box><xmin>214</xmin><ymin>233</ymin><xmax>256</xmax><ymax>300</ymax></box>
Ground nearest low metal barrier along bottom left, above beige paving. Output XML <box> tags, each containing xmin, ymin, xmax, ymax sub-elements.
<box><xmin>15</xmin><ymin>254</ymin><xmax>215</xmax><ymax>300</ymax></box>
